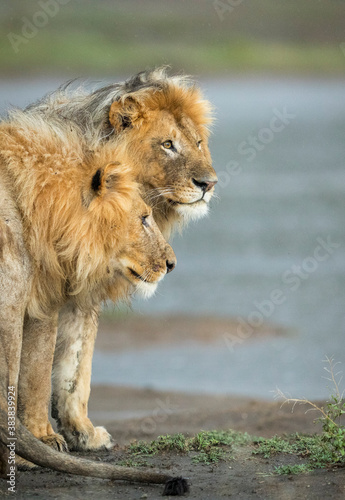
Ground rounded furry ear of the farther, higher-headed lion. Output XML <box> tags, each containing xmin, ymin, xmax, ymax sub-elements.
<box><xmin>109</xmin><ymin>97</ymin><xmax>144</xmax><ymax>133</ymax></box>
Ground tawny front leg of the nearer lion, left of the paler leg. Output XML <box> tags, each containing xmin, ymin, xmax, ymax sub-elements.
<box><xmin>18</xmin><ymin>314</ymin><xmax>67</xmax><ymax>451</ymax></box>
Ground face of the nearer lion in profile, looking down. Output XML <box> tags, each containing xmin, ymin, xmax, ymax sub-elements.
<box><xmin>117</xmin><ymin>195</ymin><xmax>176</xmax><ymax>298</ymax></box>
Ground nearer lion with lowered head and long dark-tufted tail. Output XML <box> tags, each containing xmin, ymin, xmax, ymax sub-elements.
<box><xmin>0</xmin><ymin>111</ymin><xmax>189</xmax><ymax>488</ymax></box>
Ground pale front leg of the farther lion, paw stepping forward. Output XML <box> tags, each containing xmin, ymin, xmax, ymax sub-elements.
<box><xmin>52</xmin><ymin>302</ymin><xmax>114</xmax><ymax>451</ymax></box>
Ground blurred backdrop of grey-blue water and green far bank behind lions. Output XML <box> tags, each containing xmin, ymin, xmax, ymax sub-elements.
<box><xmin>0</xmin><ymin>0</ymin><xmax>345</xmax><ymax>399</ymax></box>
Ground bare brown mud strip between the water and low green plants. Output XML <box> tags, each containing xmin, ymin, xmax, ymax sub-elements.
<box><xmin>89</xmin><ymin>386</ymin><xmax>324</xmax><ymax>445</ymax></box>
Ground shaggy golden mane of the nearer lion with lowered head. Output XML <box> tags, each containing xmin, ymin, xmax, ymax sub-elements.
<box><xmin>0</xmin><ymin>113</ymin><xmax>138</xmax><ymax>318</ymax></box>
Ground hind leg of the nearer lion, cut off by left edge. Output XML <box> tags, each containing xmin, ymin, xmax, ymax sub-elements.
<box><xmin>0</xmin><ymin>212</ymin><xmax>31</xmax><ymax>479</ymax></box>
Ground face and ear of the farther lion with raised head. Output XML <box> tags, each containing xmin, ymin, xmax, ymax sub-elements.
<box><xmin>109</xmin><ymin>89</ymin><xmax>217</xmax><ymax>235</ymax></box>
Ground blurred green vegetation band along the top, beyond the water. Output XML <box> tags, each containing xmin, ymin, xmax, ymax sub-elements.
<box><xmin>0</xmin><ymin>0</ymin><xmax>345</xmax><ymax>76</ymax></box>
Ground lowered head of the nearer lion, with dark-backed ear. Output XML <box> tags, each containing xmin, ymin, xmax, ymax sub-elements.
<box><xmin>71</xmin><ymin>154</ymin><xmax>176</xmax><ymax>300</ymax></box>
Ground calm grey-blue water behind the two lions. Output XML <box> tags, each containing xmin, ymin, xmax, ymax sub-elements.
<box><xmin>0</xmin><ymin>78</ymin><xmax>345</xmax><ymax>398</ymax></box>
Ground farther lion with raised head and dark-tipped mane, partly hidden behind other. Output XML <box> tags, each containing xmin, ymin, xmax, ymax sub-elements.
<box><xmin>22</xmin><ymin>68</ymin><xmax>217</xmax><ymax>451</ymax></box>
